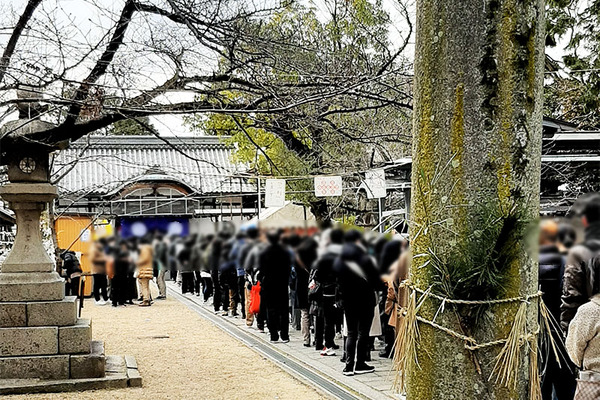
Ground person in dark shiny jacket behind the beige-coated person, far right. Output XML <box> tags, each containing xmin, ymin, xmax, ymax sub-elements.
<box><xmin>560</xmin><ymin>193</ymin><xmax>600</xmax><ymax>333</ymax></box>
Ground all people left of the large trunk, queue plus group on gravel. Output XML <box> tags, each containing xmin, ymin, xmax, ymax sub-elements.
<box><xmin>61</xmin><ymin>226</ymin><xmax>407</xmax><ymax>375</ymax></box>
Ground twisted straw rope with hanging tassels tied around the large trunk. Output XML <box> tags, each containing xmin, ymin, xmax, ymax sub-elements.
<box><xmin>394</xmin><ymin>280</ymin><xmax>558</xmax><ymax>400</ymax></box>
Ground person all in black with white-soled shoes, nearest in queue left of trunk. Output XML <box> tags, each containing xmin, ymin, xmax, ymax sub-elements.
<box><xmin>334</xmin><ymin>230</ymin><xmax>384</xmax><ymax>376</ymax></box>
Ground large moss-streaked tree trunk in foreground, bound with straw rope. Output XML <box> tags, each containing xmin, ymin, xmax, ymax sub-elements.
<box><xmin>407</xmin><ymin>0</ymin><xmax>544</xmax><ymax>400</ymax></box>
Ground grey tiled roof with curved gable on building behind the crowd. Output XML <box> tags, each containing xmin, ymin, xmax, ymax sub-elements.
<box><xmin>52</xmin><ymin>136</ymin><xmax>255</xmax><ymax>195</ymax></box>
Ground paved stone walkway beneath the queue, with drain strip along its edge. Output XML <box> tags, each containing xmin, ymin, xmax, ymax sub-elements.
<box><xmin>168</xmin><ymin>282</ymin><xmax>403</xmax><ymax>400</ymax></box>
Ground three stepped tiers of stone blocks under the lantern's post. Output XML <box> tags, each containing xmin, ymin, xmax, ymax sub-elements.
<box><xmin>0</xmin><ymin>296</ymin><xmax>106</xmax><ymax>379</ymax></box>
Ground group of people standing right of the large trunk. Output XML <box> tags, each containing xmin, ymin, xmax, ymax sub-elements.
<box><xmin>539</xmin><ymin>194</ymin><xmax>600</xmax><ymax>400</ymax></box>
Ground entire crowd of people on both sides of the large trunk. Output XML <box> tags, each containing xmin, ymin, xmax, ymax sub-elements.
<box><xmin>55</xmin><ymin>195</ymin><xmax>600</xmax><ymax>390</ymax></box>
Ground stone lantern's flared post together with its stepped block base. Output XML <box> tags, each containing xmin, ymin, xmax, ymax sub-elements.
<box><xmin>0</xmin><ymin>183</ymin><xmax>106</xmax><ymax>380</ymax></box>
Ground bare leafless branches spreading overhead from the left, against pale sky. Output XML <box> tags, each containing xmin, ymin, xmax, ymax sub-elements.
<box><xmin>0</xmin><ymin>0</ymin><xmax>409</xmax><ymax>154</ymax></box>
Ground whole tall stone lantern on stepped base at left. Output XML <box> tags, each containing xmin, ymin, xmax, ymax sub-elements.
<box><xmin>0</xmin><ymin>89</ymin><xmax>141</xmax><ymax>395</ymax></box>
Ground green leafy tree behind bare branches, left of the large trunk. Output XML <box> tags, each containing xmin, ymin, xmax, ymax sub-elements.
<box><xmin>187</xmin><ymin>0</ymin><xmax>412</xmax><ymax>218</ymax></box>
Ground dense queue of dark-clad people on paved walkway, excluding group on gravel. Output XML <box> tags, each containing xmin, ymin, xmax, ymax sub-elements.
<box><xmin>163</xmin><ymin>227</ymin><xmax>407</xmax><ymax>375</ymax></box>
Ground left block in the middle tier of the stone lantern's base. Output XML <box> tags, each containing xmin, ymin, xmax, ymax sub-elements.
<box><xmin>0</xmin><ymin>326</ymin><xmax>58</xmax><ymax>357</ymax></box>
